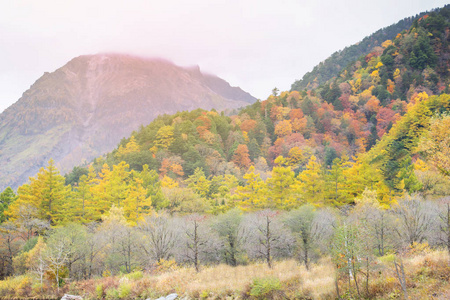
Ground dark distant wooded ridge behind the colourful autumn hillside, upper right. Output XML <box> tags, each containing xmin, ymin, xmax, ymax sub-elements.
<box><xmin>291</xmin><ymin>7</ymin><xmax>438</xmax><ymax>91</ymax></box>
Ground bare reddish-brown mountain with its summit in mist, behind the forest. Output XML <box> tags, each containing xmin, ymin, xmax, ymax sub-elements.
<box><xmin>0</xmin><ymin>54</ymin><xmax>256</xmax><ymax>190</ymax></box>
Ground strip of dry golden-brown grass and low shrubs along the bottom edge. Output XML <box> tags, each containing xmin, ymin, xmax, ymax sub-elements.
<box><xmin>0</xmin><ymin>247</ymin><xmax>450</xmax><ymax>299</ymax></box>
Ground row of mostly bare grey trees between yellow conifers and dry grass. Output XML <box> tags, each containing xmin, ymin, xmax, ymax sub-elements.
<box><xmin>1</xmin><ymin>197</ymin><xmax>450</xmax><ymax>294</ymax></box>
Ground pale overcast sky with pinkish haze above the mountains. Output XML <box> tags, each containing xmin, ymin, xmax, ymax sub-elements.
<box><xmin>0</xmin><ymin>0</ymin><xmax>446</xmax><ymax>112</ymax></box>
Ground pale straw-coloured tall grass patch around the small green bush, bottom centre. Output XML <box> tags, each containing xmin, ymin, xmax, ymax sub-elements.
<box><xmin>149</xmin><ymin>260</ymin><xmax>334</xmax><ymax>299</ymax></box>
